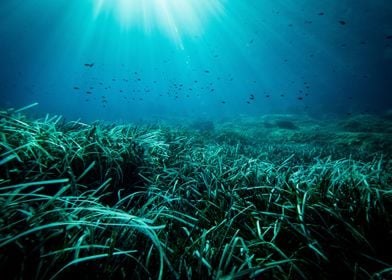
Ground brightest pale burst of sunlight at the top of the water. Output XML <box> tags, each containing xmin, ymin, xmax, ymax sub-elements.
<box><xmin>94</xmin><ymin>0</ymin><xmax>224</xmax><ymax>45</ymax></box>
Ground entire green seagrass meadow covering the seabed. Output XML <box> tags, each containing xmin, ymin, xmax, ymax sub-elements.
<box><xmin>0</xmin><ymin>106</ymin><xmax>392</xmax><ymax>279</ymax></box>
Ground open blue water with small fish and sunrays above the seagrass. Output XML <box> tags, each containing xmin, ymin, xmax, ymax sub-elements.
<box><xmin>0</xmin><ymin>0</ymin><xmax>392</xmax><ymax>121</ymax></box>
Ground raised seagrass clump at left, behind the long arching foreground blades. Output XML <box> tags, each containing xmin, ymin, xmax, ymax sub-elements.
<box><xmin>0</xmin><ymin>106</ymin><xmax>155</xmax><ymax>203</ymax></box>
